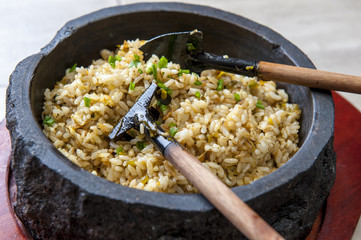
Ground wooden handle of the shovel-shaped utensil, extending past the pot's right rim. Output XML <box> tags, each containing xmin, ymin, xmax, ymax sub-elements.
<box><xmin>258</xmin><ymin>61</ymin><xmax>361</xmax><ymax>93</ymax></box>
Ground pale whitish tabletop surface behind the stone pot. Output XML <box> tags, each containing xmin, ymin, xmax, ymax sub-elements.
<box><xmin>0</xmin><ymin>0</ymin><xmax>361</xmax><ymax>239</ymax></box>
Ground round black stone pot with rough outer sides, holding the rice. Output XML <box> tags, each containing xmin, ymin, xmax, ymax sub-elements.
<box><xmin>6</xmin><ymin>3</ymin><xmax>336</xmax><ymax>239</ymax></box>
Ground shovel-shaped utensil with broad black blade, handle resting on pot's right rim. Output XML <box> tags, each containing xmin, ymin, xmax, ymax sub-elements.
<box><xmin>140</xmin><ymin>30</ymin><xmax>361</xmax><ymax>93</ymax></box>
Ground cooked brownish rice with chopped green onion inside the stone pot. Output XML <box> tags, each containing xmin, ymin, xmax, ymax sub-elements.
<box><xmin>43</xmin><ymin>40</ymin><xmax>301</xmax><ymax>193</ymax></box>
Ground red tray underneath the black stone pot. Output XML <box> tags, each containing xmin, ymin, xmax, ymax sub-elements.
<box><xmin>0</xmin><ymin>92</ymin><xmax>361</xmax><ymax>240</ymax></box>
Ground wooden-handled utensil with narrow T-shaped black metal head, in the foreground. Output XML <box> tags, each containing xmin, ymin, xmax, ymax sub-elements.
<box><xmin>109</xmin><ymin>83</ymin><xmax>283</xmax><ymax>240</ymax></box>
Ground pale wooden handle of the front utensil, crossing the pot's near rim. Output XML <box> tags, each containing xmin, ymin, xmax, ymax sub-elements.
<box><xmin>164</xmin><ymin>143</ymin><xmax>284</xmax><ymax>239</ymax></box>
